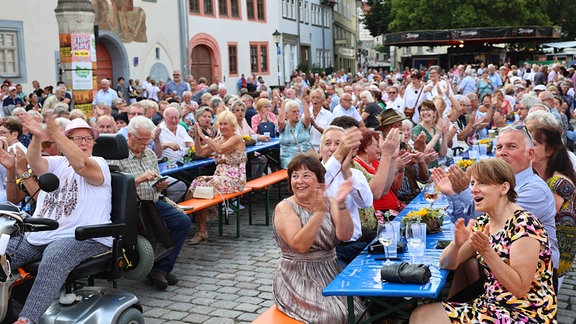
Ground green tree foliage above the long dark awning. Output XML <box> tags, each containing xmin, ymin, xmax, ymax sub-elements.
<box><xmin>362</xmin><ymin>0</ymin><xmax>564</xmax><ymax>38</ymax></box>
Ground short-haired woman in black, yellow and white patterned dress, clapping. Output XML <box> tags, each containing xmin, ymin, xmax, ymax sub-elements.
<box><xmin>410</xmin><ymin>159</ymin><xmax>557</xmax><ymax>323</ymax></box>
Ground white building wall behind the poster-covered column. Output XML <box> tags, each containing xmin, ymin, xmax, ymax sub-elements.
<box><xmin>0</xmin><ymin>0</ymin><xmax>180</xmax><ymax>93</ymax></box>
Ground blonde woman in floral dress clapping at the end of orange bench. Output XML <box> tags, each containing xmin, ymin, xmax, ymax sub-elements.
<box><xmin>186</xmin><ymin>111</ymin><xmax>246</xmax><ymax>245</ymax></box>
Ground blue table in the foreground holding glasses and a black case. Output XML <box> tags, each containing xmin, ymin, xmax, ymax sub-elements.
<box><xmin>322</xmin><ymin>193</ymin><xmax>453</xmax><ymax>323</ymax></box>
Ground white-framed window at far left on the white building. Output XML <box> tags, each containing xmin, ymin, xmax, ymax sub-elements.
<box><xmin>0</xmin><ymin>20</ymin><xmax>26</xmax><ymax>79</ymax></box>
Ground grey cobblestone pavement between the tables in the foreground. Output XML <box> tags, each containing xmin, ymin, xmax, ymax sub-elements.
<box><xmin>119</xmin><ymin>195</ymin><xmax>576</xmax><ymax>324</ymax></box>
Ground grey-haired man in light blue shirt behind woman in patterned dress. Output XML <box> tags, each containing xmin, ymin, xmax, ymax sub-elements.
<box><xmin>434</xmin><ymin>126</ymin><xmax>560</xmax><ymax>286</ymax></box>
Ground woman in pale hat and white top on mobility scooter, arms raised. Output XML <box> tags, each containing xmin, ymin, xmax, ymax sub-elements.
<box><xmin>7</xmin><ymin>114</ymin><xmax>112</xmax><ymax>324</ymax></box>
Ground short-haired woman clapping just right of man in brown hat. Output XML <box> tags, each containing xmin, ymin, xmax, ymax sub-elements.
<box><xmin>412</xmin><ymin>100</ymin><xmax>454</xmax><ymax>168</ymax></box>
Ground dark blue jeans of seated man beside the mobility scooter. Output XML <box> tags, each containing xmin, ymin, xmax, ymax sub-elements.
<box><xmin>153</xmin><ymin>200</ymin><xmax>192</xmax><ymax>274</ymax></box>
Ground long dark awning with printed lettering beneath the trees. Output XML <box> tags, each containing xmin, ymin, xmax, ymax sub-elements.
<box><xmin>384</xmin><ymin>26</ymin><xmax>561</xmax><ymax>46</ymax></box>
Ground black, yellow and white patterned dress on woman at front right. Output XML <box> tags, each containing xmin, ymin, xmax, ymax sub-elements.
<box><xmin>443</xmin><ymin>210</ymin><xmax>557</xmax><ymax>323</ymax></box>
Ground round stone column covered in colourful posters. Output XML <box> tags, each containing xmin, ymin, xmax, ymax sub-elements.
<box><xmin>54</xmin><ymin>0</ymin><xmax>97</xmax><ymax>116</ymax></box>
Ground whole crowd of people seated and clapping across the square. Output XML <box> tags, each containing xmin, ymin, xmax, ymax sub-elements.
<box><xmin>0</xmin><ymin>59</ymin><xmax>576</xmax><ymax>323</ymax></box>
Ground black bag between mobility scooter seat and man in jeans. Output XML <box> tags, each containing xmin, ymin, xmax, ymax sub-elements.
<box><xmin>138</xmin><ymin>199</ymin><xmax>174</xmax><ymax>261</ymax></box>
